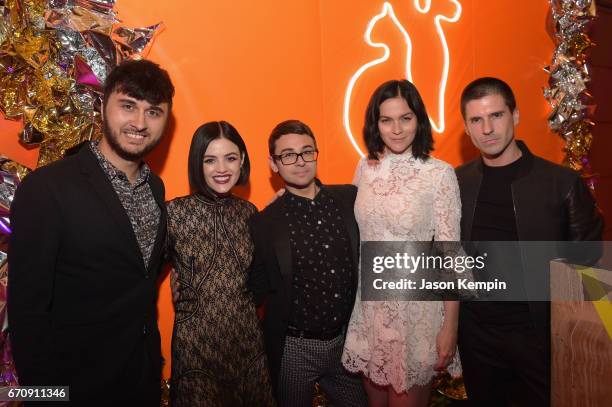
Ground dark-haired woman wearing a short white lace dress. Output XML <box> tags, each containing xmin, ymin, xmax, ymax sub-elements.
<box><xmin>342</xmin><ymin>80</ymin><xmax>461</xmax><ymax>406</ymax></box>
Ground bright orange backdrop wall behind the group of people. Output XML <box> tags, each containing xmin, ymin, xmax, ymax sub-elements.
<box><xmin>0</xmin><ymin>0</ymin><xmax>562</xmax><ymax>377</ymax></box>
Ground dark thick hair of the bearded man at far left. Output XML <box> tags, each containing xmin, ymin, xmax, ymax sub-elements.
<box><xmin>104</xmin><ymin>59</ymin><xmax>174</xmax><ymax>107</ymax></box>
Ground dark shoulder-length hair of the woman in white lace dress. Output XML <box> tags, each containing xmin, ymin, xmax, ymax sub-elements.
<box><xmin>363</xmin><ymin>79</ymin><xmax>433</xmax><ymax>160</ymax></box>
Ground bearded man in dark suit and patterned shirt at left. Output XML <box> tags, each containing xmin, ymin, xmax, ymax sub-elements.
<box><xmin>8</xmin><ymin>60</ymin><xmax>174</xmax><ymax>406</ymax></box>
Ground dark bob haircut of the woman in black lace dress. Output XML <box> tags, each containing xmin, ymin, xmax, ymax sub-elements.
<box><xmin>187</xmin><ymin>121</ymin><xmax>251</xmax><ymax>199</ymax></box>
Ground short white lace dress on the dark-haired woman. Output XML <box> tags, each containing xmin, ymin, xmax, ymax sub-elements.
<box><xmin>342</xmin><ymin>152</ymin><xmax>461</xmax><ymax>393</ymax></box>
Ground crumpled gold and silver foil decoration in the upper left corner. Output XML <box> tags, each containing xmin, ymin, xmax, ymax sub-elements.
<box><xmin>0</xmin><ymin>0</ymin><xmax>161</xmax><ymax>166</ymax></box>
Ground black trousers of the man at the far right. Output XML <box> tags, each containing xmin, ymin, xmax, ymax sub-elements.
<box><xmin>458</xmin><ymin>312</ymin><xmax>550</xmax><ymax>407</ymax></box>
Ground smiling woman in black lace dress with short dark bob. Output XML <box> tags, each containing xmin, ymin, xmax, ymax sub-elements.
<box><xmin>168</xmin><ymin>121</ymin><xmax>274</xmax><ymax>407</ymax></box>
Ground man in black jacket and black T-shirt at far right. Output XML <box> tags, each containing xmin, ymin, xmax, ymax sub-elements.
<box><xmin>457</xmin><ymin>78</ymin><xmax>603</xmax><ymax>407</ymax></box>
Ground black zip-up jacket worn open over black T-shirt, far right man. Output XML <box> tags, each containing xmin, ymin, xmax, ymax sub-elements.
<box><xmin>456</xmin><ymin>141</ymin><xmax>604</xmax><ymax>327</ymax></box>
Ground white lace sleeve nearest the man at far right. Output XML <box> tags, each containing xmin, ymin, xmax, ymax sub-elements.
<box><xmin>434</xmin><ymin>164</ymin><xmax>461</xmax><ymax>241</ymax></box>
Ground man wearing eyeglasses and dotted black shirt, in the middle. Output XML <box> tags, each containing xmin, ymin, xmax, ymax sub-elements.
<box><xmin>248</xmin><ymin>120</ymin><xmax>367</xmax><ymax>407</ymax></box>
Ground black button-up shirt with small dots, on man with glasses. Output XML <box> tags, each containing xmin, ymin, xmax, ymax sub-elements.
<box><xmin>283</xmin><ymin>189</ymin><xmax>355</xmax><ymax>333</ymax></box>
